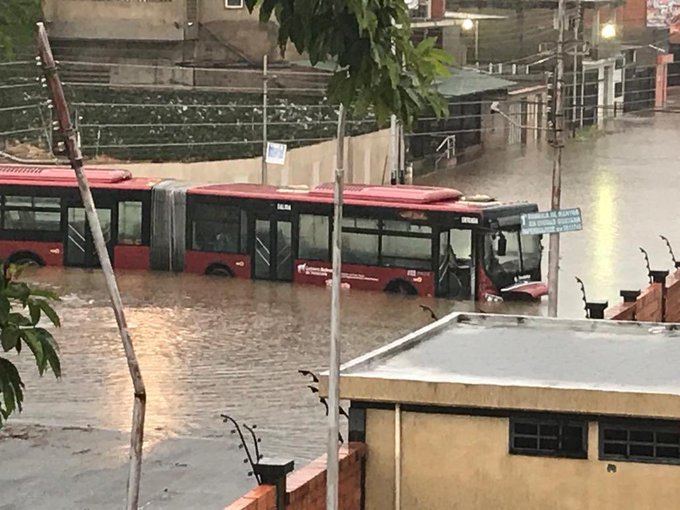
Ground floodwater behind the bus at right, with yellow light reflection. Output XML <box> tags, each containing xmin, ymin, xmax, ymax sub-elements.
<box><xmin>423</xmin><ymin>114</ymin><xmax>680</xmax><ymax>317</ymax></box>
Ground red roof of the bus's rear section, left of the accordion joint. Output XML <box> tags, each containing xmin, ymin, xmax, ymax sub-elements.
<box><xmin>0</xmin><ymin>165</ymin><xmax>159</xmax><ymax>190</ymax></box>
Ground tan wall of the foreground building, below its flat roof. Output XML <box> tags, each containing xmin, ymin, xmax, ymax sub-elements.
<box><xmin>366</xmin><ymin>410</ymin><xmax>680</xmax><ymax>510</ymax></box>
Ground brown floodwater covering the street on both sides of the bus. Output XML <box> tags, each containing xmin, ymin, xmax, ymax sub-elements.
<box><xmin>9</xmin><ymin>109</ymin><xmax>680</xmax><ymax>461</ymax></box>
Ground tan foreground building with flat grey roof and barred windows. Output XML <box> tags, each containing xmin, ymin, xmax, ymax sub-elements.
<box><xmin>321</xmin><ymin>314</ymin><xmax>680</xmax><ymax>510</ymax></box>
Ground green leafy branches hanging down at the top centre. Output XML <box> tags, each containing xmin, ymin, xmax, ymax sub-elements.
<box><xmin>246</xmin><ymin>0</ymin><xmax>451</xmax><ymax>127</ymax></box>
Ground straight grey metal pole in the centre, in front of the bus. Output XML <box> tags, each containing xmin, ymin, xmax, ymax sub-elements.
<box><xmin>326</xmin><ymin>104</ymin><xmax>345</xmax><ymax>510</ymax></box>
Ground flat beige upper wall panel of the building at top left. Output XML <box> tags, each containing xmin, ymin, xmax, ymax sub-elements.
<box><xmin>42</xmin><ymin>0</ymin><xmax>186</xmax><ymax>41</ymax></box>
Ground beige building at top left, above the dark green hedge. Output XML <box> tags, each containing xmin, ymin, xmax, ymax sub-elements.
<box><xmin>42</xmin><ymin>0</ymin><xmax>280</xmax><ymax>66</ymax></box>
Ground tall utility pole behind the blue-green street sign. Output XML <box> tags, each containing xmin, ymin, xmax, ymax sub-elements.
<box><xmin>548</xmin><ymin>0</ymin><xmax>567</xmax><ymax>317</ymax></box>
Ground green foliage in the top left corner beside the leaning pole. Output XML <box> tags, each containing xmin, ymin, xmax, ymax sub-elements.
<box><xmin>0</xmin><ymin>0</ymin><xmax>42</xmax><ymax>60</ymax></box>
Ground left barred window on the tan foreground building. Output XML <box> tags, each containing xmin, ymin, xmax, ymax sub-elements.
<box><xmin>510</xmin><ymin>416</ymin><xmax>588</xmax><ymax>459</ymax></box>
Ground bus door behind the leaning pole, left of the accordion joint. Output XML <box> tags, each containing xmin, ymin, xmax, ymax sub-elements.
<box><xmin>64</xmin><ymin>207</ymin><xmax>111</xmax><ymax>267</ymax></box>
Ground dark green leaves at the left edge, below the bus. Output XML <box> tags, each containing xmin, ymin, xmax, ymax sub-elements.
<box><xmin>0</xmin><ymin>261</ymin><xmax>61</xmax><ymax>428</ymax></box>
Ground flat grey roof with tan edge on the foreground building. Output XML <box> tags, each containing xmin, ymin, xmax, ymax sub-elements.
<box><xmin>330</xmin><ymin>313</ymin><xmax>680</xmax><ymax>418</ymax></box>
